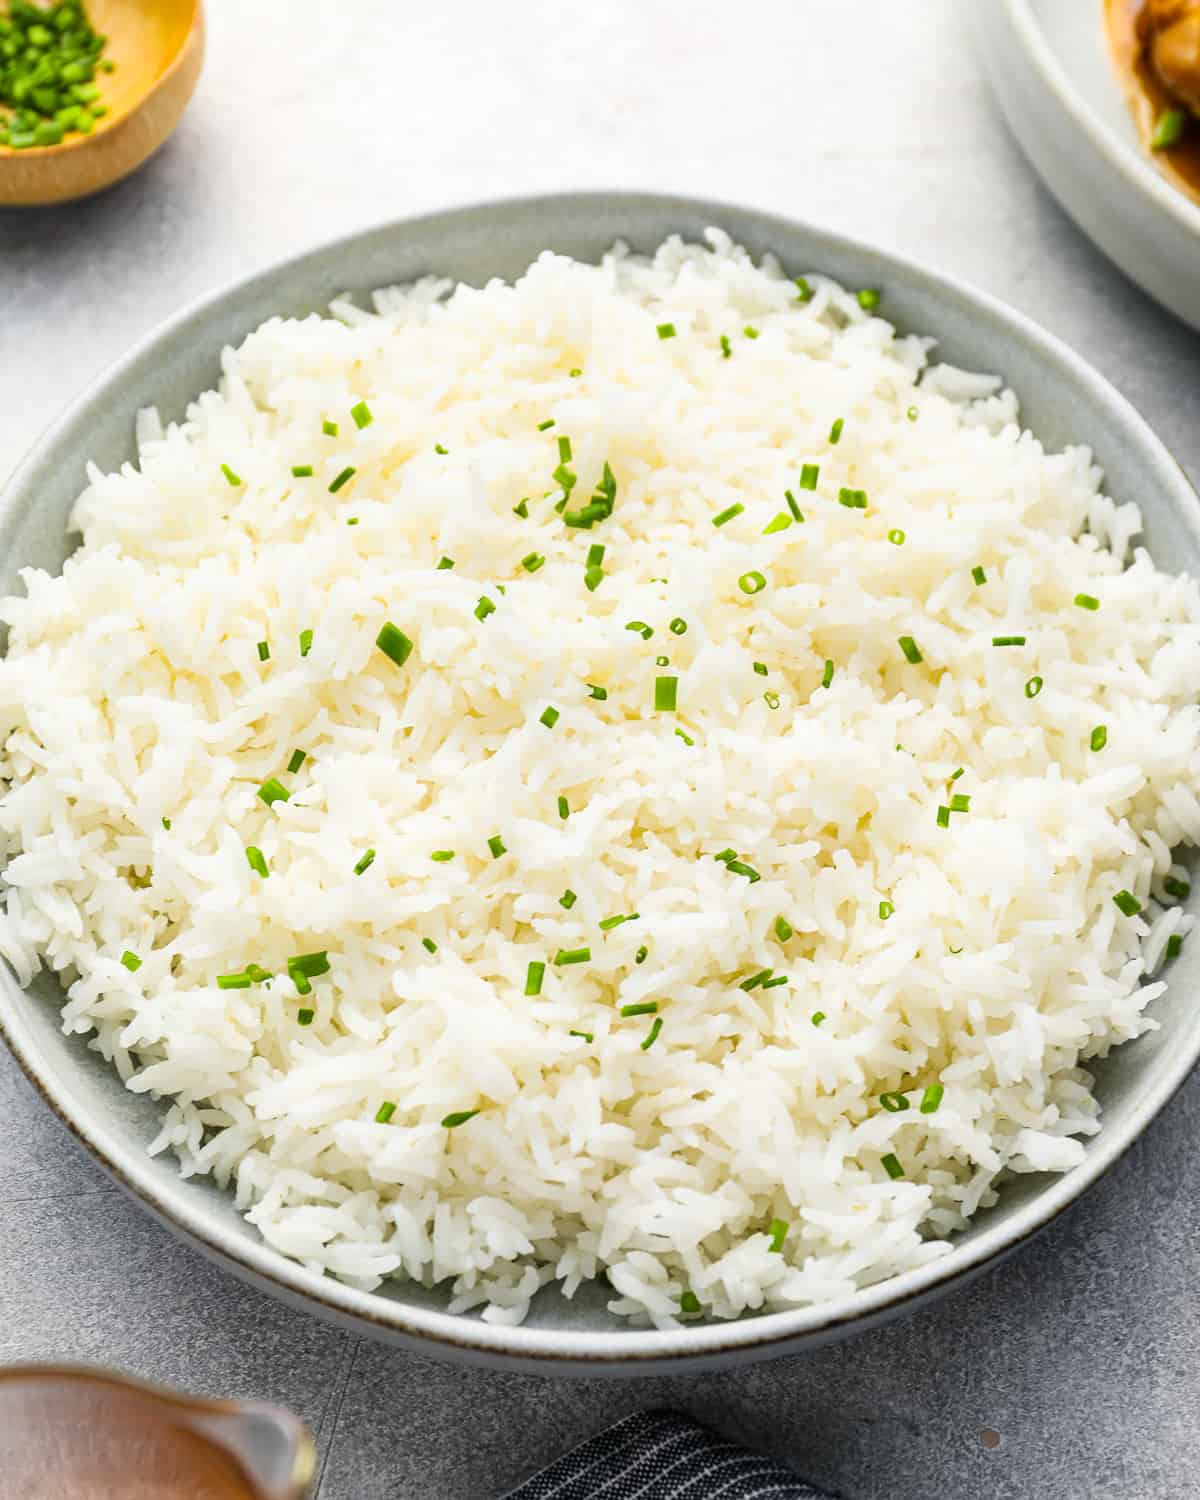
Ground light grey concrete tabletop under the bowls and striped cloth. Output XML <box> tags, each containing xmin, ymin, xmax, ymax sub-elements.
<box><xmin>0</xmin><ymin>0</ymin><xmax>1200</xmax><ymax>1500</ymax></box>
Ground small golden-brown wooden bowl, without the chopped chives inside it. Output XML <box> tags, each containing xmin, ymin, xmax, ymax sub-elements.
<box><xmin>0</xmin><ymin>0</ymin><xmax>204</xmax><ymax>206</ymax></box>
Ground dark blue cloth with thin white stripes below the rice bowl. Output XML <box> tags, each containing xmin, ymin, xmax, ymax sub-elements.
<box><xmin>506</xmin><ymin>1412</ymin><xmax>836</xmax><ymax>1500</ymax></box>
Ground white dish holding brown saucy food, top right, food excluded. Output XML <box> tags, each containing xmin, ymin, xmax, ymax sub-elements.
<box><xmin>972</xmin><ymin>0</ymin><xmax>1200</xmax><ymax>329</ymax></box>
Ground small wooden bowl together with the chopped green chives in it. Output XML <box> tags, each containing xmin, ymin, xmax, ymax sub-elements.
<box><xmin>0</xmin><ymin>0</ymin><xmax>204</xmax><ymax>207</ymax></box>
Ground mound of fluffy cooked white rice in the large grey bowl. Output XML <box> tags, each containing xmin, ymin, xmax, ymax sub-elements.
<box><xmin>0</xmin><ymin>233</ymin><xmax>1200</xmax><ymax>1326</ymax></box>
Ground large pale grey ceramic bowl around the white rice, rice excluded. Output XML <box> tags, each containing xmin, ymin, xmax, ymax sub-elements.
<box><xmin>0</xmin><ymin>194</ymin><xmax>1200</xmax><ymax>1374</ymax></box>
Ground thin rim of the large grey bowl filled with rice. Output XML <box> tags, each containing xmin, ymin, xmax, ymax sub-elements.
<box><xmin>0</xmin><ymin>193</ymin><xmax>1200</xmax><ymax>1376</ymax></box>
